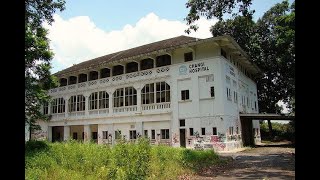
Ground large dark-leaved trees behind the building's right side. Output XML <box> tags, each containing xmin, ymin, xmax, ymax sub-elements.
<box><xmin>186</xmin><ymin>0</ymin><xmax>295</xmax><ymax>136</ymax></box>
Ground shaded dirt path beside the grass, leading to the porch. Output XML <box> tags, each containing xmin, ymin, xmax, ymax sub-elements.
<box><xmin>192</xmin><ymin>144</ymin><xmax>295</xmax><ymax>180</ymax></box>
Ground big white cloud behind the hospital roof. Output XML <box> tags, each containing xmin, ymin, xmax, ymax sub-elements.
<box><xmin>46</xmin><ymin>13</ymin><xmax>217</xmax><ymax>73</ymax></box>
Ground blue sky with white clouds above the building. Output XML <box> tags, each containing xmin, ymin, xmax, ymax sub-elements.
<box><xmin>47</xmin><ymin>0</ymin><xmax>293</xmax><ymax>73</ymax></box>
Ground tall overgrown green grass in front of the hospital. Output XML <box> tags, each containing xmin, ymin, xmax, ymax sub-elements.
<box><xmin>25</xmin><ymin>138</ymin><xmax>223</xmax><ymax>180</ymax></box>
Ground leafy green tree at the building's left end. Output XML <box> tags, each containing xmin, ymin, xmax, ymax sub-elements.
<box><xmin>25</xmin><ymin>0</ymin><xmax>65</xmax><ymax>139</ymax></box>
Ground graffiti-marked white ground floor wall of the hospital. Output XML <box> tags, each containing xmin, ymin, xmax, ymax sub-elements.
<box><xmin>33</xmin><ymin>114</ymin><xmax>261</xmax><ymax>151</ymax></box>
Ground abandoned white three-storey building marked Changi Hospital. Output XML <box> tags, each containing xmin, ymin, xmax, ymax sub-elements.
<box><xmin>32</xmin><ymin>36</ymin><xmax>261</xmax><ymax>151</ymax></box>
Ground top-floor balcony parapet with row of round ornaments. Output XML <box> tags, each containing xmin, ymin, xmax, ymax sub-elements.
<box><xmin>49</xmin><ymin>66</ymin><xmax>170</xmax><ymax>96</ymax></box>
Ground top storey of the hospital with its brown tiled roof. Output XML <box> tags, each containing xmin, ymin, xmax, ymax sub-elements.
<box><xmin>49</xmin><ymin>36</ymin><xmax>259</xmax><ymax>95</ymax></box>
